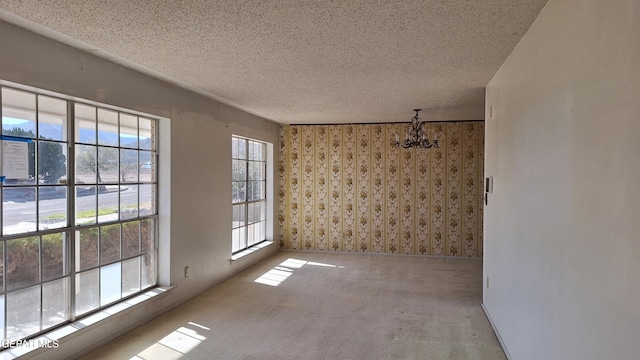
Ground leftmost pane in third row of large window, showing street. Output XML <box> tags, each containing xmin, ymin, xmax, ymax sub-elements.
<box><xmin>2</xmin><ymin>187</ymin><xmax>37</xmax><ymax>235</ymax></box>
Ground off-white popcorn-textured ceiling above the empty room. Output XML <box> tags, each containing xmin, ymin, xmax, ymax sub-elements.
<box><xmin>0</xmin><ymin>0</ymin><xmax>547</xmax><ymax>124</ymax></box>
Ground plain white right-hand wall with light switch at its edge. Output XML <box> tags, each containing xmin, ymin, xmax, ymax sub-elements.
<box><xmin>484</xmin><ymin>0</ymin><xmax>640</xmax><ymax>360</ymax></box>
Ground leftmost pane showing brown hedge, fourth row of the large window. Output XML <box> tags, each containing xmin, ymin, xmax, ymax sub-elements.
<box><xmin>6</xmin><ymin>236</ymin><xmax>40</xmax><ymax>290</ymax></box>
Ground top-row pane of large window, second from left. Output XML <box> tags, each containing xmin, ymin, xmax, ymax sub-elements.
<box><xmin>38</xmin><ymin>95</ymin><xmax>67</xmax><ymax>141</ymax></box>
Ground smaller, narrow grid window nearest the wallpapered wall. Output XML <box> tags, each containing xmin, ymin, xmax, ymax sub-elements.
<box><xmin>231</xmin><ymin>136</ymin><xmax>267</xmax><ymax>253</ymax></box>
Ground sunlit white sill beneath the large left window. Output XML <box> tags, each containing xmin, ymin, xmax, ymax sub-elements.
<box><xmin>0</xmin><ymin>286</ymin><xmax>175</xmax><ymax>360</ymax></box>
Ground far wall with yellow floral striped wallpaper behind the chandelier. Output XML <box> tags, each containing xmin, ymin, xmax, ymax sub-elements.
<box><xmin>278</xmin><ymin>121</ymin><xmax>484</xmax><ymax>257</ymax></box>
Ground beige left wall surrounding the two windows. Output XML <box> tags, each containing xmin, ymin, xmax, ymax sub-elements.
<box><xmin>0</xmin><ymin>22</ymin><xmax>279</xmax><ymax>359</ymax></box>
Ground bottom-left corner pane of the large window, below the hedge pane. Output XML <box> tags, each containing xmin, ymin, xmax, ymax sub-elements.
<box><xmin>7</xmin><ymin>285</ymin><xmax>40</xmax><ymax>340</ymax></box>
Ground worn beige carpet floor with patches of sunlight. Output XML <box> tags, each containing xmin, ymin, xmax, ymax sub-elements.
<box><xmin>77</xmin><ymin>251</ymin><xmax>506</xmax><ymax>360</ymax></box>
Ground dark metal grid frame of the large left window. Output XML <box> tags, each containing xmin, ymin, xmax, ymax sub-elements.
<box><xmin>0</xmin><ymin>82</ymin><xmax>160</xmax><ymax>341</ymax></box>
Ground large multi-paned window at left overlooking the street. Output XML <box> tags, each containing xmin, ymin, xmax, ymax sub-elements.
<box><xmin>0</xmin><ymin>87</ymin><xmax>157</xmax><ymax>341</ymax></box>
